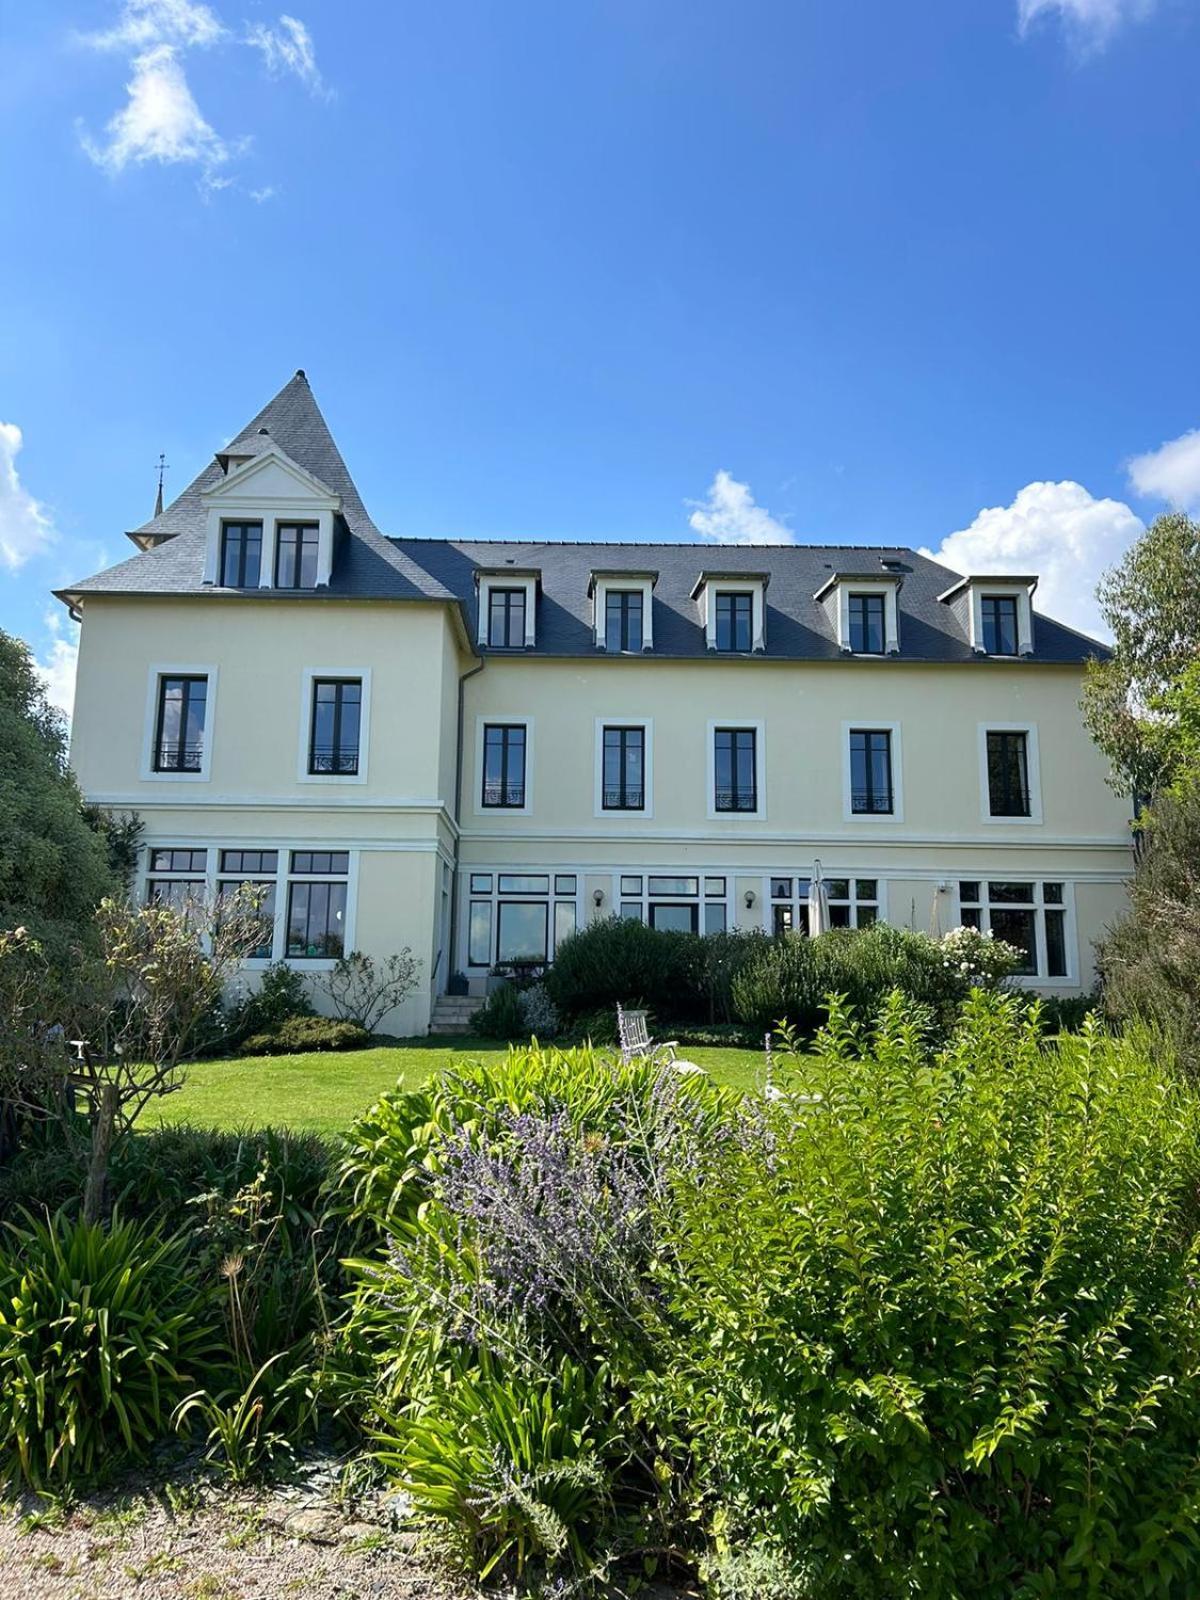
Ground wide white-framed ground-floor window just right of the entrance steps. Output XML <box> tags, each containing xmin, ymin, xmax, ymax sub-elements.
<box><xmin>467</xmin><ymin>872</ymin><xmax>579</xmax><ymax>968</ymax></box>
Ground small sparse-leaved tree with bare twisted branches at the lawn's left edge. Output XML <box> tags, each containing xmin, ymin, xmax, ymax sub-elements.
<box><xmin>0</xmin><ymin>886</ymin><xmax>270</xmax><ymax>1222</ymax></box>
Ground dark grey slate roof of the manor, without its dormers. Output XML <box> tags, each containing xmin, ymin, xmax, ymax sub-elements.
<box><xmin>58</xmin><ymin>371</ymin><xmax>1106</xmax><ymax>664</ymax></box>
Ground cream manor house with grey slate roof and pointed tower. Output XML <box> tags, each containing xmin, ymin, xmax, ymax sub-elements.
<box><xmin>61</xmin><ymin>371</ymin><xmax>1130</xmax><ymax>1034</ymax></box>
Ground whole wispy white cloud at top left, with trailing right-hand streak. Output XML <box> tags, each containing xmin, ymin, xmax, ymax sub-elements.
<box><xmin>80</xmin><ymin>0</ymin><xmax>330</xmax><ymax>190</ymax></box>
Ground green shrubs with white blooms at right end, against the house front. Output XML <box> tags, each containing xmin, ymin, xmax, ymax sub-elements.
<box><xmin>731</xmin><ymin>922</ymin><xmax>1018</xmax><ymax>1035</ymax></box>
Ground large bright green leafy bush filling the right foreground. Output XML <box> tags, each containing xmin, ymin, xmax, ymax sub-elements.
<box><xmin>652</xmin><ymin>992</ymin><xmax>1200</xmax><ymax>1600</ymax></box>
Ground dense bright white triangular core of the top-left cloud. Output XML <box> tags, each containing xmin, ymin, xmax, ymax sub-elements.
<box><xmin>83</xmin><ymin>45</ymin><xmax>229</xmax><ymax>173</ymax></box>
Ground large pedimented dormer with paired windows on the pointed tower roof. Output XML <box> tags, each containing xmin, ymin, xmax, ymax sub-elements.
<box><xmin>200</xmin><ymin>429</ymin><xmax>341</xmax><ymax>592</ymax></box>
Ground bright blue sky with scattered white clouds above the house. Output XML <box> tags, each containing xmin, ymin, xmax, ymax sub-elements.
<box><xmin>0</xmin><ymin>0</ymin><xmax>1200</xmax><ymax>713</ymax></box>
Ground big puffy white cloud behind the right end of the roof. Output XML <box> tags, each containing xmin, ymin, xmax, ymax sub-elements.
<box><xmin>922</xmin><ymin>482</ymin><xmax>1142</xmax><ymax>635</ymax></box>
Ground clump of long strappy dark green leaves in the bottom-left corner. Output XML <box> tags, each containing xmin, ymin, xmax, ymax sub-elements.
<box><xmin>0</xmin><ymin>1213</ymin><xmax>219</xmax><ymax>1488</ymax></box>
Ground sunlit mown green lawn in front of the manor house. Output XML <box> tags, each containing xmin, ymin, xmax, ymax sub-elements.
<box><xmin>144</xmin><ymin>1038</ymin><xmax>763</xmax><ymax>1133</ymax></box>
